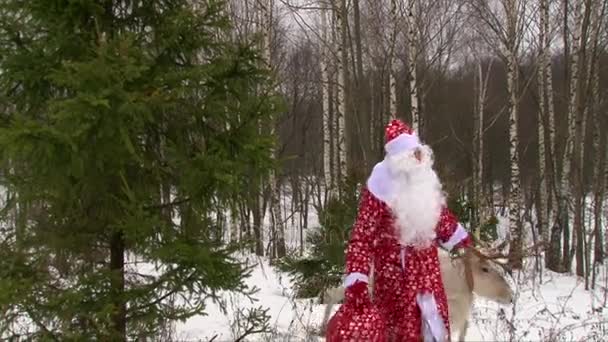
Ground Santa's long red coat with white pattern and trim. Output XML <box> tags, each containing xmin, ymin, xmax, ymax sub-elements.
<box><xmin>328</xmin><ymin>188</ymin><xmax>471</xmax><ymax>341</ymax></box>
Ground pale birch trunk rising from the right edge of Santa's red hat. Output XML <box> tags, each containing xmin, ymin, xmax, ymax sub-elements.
<box><xmin>407</xmin><ymin>0</ymin><xmax>423</xmax><ymax>136</ymax></box>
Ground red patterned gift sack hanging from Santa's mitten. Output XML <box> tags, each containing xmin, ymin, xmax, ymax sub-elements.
<box><xmin>326</xmin><ymin>281</ymin><xmax>386</xmax><ymax>342</ymax></box>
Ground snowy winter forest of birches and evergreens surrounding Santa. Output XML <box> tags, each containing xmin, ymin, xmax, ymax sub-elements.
<box><xmin>0</xmin><ymin>0</ymin><xmax>608</xmax><ymax>342</ymax></box>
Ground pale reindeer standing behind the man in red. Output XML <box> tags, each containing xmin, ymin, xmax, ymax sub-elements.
<box><xmin>321</xmin><ymin>248</ymin><xmax>513</xmax><ymax>341</ymax></box>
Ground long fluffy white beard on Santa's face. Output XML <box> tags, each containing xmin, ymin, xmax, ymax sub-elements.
<box><xmin>386</xmin><ymin>146</ymin><xmax>445</xmax><ymax>248</ymax></box>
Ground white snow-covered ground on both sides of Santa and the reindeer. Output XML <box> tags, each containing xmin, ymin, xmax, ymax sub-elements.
<box><xmin>175</xmin><ymin>195</ymin><xmax>608</xmax><ymax>342</ymax></box>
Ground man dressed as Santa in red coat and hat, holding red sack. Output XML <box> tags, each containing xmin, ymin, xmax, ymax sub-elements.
<box><xmin>327</xmin><ymin>120</ymin><xmax>471</xmax><ymax>342</ymax></box>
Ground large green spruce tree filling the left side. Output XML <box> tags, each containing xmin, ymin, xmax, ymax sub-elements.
<box><xmin>0</xmin><ymin>0</ymin><xmax>278</xmax><ymax>341</ymax></box>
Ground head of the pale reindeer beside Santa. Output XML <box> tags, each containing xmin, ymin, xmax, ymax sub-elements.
<box><xmin>465</xmin><ymin>248</ymin><xmax>513</xmax><ymax>304</ymax></box>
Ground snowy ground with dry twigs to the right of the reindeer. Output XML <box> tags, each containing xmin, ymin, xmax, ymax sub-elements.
<box><xmin>467</xmin><ymin>259</ymin><xmax>608</xmax><ymax>341</ymax></box>
